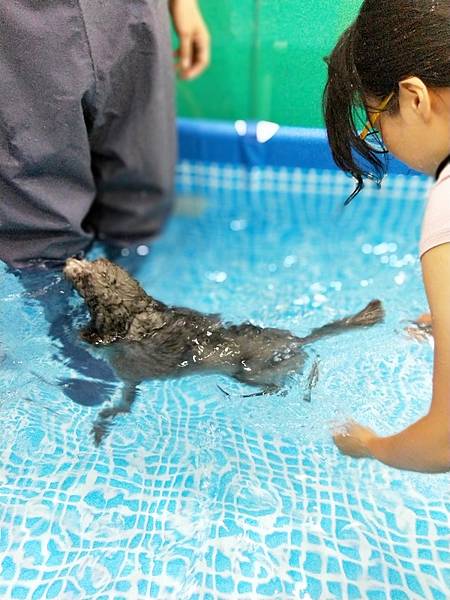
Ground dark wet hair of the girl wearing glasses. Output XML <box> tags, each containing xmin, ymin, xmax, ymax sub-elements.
<box><xmin>323</xmin><ymin>0</ymin><xmax>450</xmax><ymax>201</ymax></box>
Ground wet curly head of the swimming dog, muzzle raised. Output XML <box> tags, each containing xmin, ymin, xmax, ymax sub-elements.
<box><xmin>64</xmin><ymin>258</ymin><xmax>148</xmax><ymax>336</ymax></box>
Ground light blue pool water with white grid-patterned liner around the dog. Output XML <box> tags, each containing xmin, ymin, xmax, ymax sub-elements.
<box><xmin>0</xmin><ymin>123</ymin><xmax>450</xmax><ymax>600</ymax></box>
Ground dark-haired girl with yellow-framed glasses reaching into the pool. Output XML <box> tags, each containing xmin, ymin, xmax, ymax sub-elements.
<box><xmin>324</xmin><ymin>0</ymin><xmax>450</xmax><ymax>472</ymax></box>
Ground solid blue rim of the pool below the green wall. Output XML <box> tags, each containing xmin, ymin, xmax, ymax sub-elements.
<box><xmin>177</xmin><ymin>118</ymin><xmax>418</xmax><ymax>175</ymax></box>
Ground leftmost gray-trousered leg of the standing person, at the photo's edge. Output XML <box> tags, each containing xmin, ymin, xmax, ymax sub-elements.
<box><xmin>0</xmin><ymin>0</ymin><xmax>95</xmax><ymax>266</ymax></box>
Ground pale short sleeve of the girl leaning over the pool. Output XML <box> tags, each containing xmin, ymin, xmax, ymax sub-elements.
<box><xmin>419</xmin><ymin>163</ymin><xmax>450</xmax><ymax>257</ymax></box>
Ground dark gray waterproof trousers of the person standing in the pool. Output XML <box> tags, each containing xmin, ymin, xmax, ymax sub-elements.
<box><xmin>0</xmin><ymin>0</ymin><xmax>176</xmax><ymax>267</ymax></box>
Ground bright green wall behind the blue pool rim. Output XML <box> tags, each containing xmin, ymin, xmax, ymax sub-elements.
<box><xmin>177</xmin><ymin>0</ymin><xmax>361</xmax><ymax>127</ymax></box>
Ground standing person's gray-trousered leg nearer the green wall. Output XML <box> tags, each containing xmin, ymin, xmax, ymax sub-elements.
<box><xmin>80</xmin><ymin>0</ymin><xmax>176</xmax><ymax>246</ymax></box>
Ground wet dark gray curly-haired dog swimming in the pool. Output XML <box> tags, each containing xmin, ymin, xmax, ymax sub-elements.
<box><xmin>64</xmin><ymin>258</ymin><xmax>384</xmax><ymax>445</ymax></box>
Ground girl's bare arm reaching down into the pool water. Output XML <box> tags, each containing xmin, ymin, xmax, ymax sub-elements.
<box><xmin>334</xmin><ymin>243</ymin><xmax>450</xmax><ymax>472</ymax></box>
